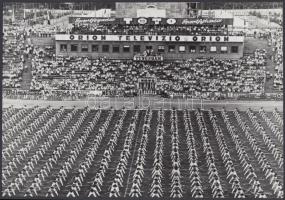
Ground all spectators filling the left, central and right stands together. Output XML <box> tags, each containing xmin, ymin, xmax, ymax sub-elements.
<box><xmin>3</xmin><ymin>18</ymin><xmax>283</xmax><ymax>98</ymax></box>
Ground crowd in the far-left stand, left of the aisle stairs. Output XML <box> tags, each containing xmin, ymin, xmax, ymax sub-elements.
<box><xmin>3</xmin><ymin>21</ymin><xmax>60</xmax><ymax>88</ymax></box>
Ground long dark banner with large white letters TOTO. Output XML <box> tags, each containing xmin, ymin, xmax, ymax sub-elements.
<box><xmin>69</xmin><ymin>17</ymin><xmax>233</xmax><ymax>26</ymax></box>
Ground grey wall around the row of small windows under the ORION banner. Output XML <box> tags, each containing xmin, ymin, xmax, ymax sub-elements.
<box><xmin>56</xmin><ymin>41</ymin><xmax>244</xmax><ymax>60</ymax></box>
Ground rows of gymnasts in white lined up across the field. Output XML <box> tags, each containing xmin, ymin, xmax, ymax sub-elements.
<box><xmin>2</xmin><ymin>106</ymin><xmax>283</xmax><ymax>198</ymax></box>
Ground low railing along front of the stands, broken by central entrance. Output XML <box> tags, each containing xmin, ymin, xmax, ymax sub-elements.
<box><xmin>2</xmin><ymin>88</ymin><xmax>283</xmax><ymax>101</ymax></box>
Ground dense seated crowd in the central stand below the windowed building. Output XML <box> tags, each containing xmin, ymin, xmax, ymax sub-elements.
<box><xmin>27</xmin><ymin>50</ymin><xmax>266</xmax><ymax>97</ymax></box>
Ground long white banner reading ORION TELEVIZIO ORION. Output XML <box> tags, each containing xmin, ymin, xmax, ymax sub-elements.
<box><xmin>55</xmin><ymin>34</ymin><xmax>244</xmax><ymax>42</ymax></box>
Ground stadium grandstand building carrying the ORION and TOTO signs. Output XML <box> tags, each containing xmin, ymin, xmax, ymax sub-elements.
<box><xmin>55</xmin><ymin>2</ymin><xmax>244</xmax><ymax>61</ymax></box>
